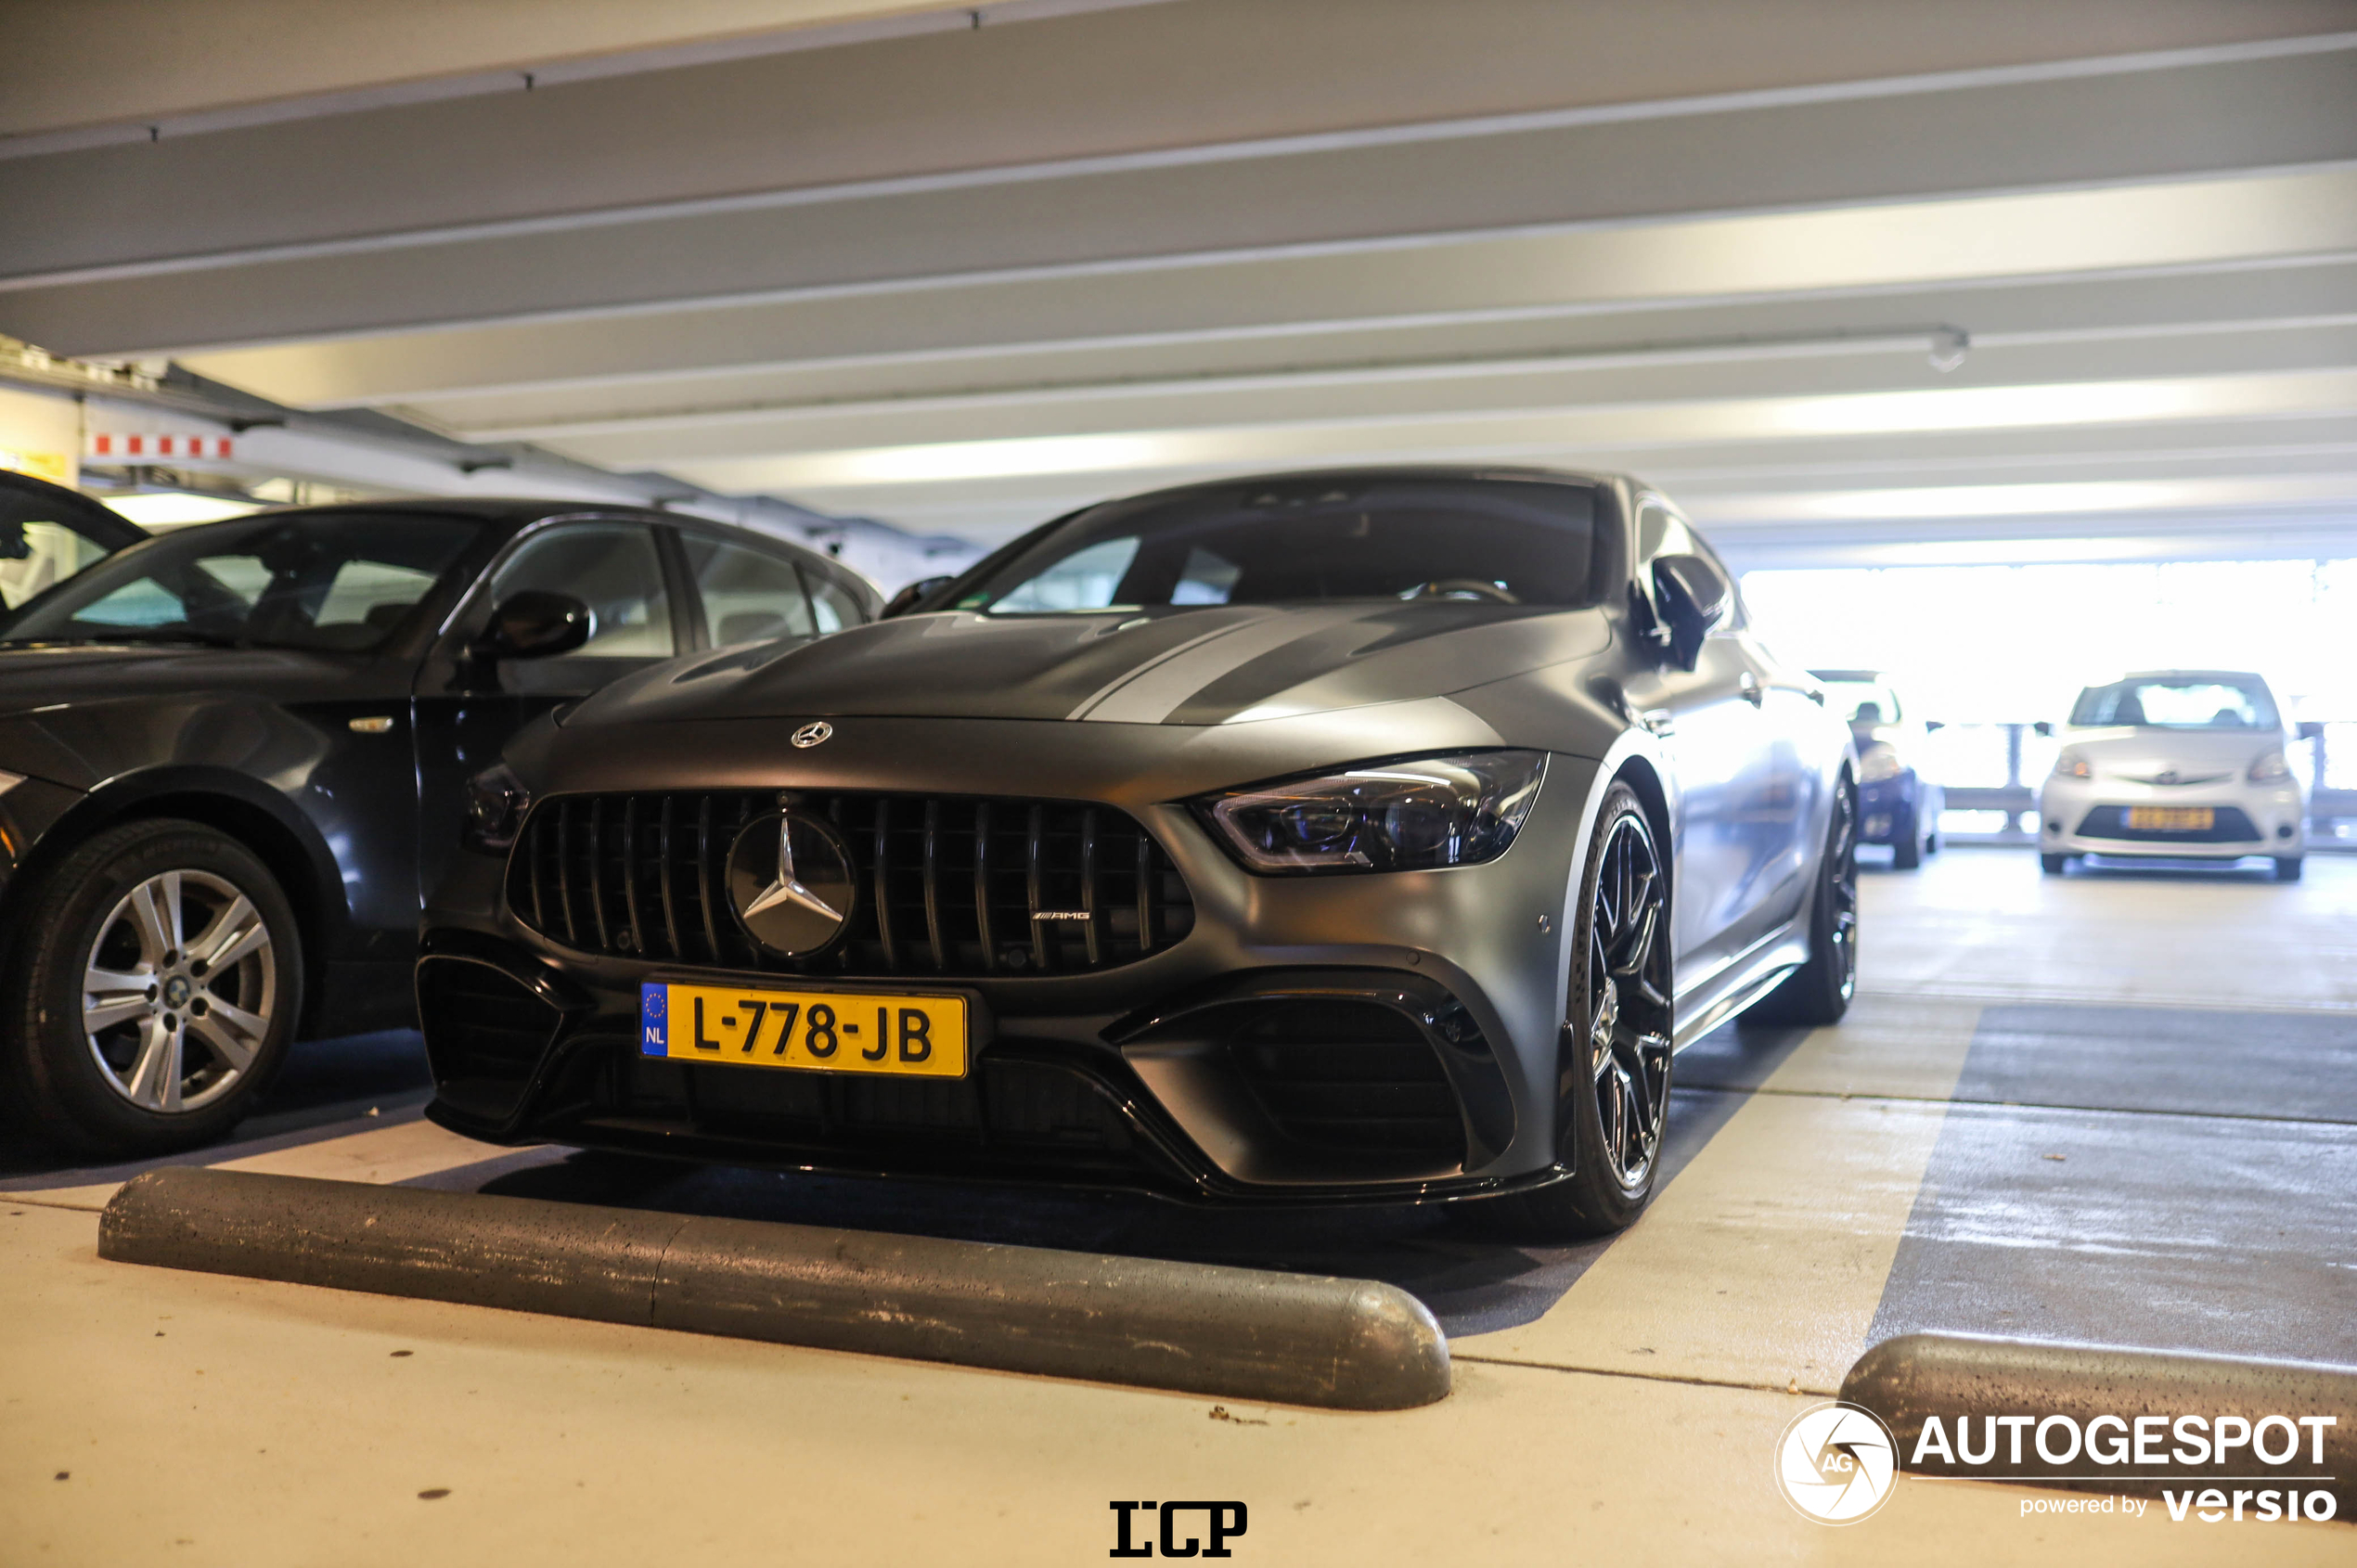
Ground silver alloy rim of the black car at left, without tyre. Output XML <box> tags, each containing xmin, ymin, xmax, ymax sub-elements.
<box><xmin>83</xmin><ymin>870</ymin><xmax>278</xmax><ymax>1115</ymax></box>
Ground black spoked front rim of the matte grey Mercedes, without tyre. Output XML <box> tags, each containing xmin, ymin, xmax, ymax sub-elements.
<box><xmin>1586</xmin><ymin>811</ymin><xmax>1668</xmax><ymax>1193</ymax></box>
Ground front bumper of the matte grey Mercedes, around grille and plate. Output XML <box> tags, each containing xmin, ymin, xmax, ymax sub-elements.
<box><xmin>419</xmin><ymin>722</ymin><xmax>1596</xmax><ymax>1201</ymax></box>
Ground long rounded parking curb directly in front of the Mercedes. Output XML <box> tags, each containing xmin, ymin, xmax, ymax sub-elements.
<box><xmin>99</xmin><ymin>1167</ymin><xmax>1449</xmax><ymax>1410</ymax></box>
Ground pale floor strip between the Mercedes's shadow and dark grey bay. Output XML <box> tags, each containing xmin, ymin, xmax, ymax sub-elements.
<box><xmin>1462</xmin><ymin>997</ymin><xmax>1980</xmax><ymax>1394</ymax></box>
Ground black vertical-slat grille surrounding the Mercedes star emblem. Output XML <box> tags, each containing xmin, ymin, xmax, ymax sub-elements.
<box><xmin>507</xmin><ymin>790</ymin><xmax>1195</xmax><ymax>976</ymax></box>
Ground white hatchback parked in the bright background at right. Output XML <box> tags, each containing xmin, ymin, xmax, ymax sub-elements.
<box><xmin>2039</xmin><ymin>670</ymin><xmax>2308</xmax><ymax>881</ymax></box>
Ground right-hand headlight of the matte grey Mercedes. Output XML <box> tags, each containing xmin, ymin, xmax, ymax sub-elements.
<box><xmin>1195</xmin><ymin>752</ymin><xmax>1546</xmax><ymax>875</ymax></box>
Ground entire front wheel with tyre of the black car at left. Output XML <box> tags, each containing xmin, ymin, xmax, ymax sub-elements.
<box><xmin>0</xmin><ymin>820</ymin><xmax>302</xmax><ymax>1155</ymax></box>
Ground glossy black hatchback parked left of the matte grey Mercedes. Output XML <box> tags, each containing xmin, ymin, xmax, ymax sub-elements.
<box><xmin>0</xmin><ymin>500</ymin><xmax>879</xmax><ymax>1153</ymax></box>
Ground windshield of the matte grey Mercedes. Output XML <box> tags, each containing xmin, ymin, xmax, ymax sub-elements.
<box><xmin>957</xmin><ymin>476</ymin><xmax>1596</xmax><ymax>615</ymax></box>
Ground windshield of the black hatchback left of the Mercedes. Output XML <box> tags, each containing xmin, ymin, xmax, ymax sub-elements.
<box><xmin>0</xmin><ymin>511</ymin><xmax>481</xmax><ymax>653</ymax></box>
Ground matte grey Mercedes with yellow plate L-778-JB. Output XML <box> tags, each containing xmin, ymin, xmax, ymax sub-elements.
<box><xmin>418</xmin><ymin>469</ymin><xmax>1858</xmax><ymax>1233</ymax></box>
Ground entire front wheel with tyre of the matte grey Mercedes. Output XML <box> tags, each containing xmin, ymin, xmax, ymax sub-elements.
<box><xmin>1475</xmin><ymin>783</ymin><xmax>1673</xmax><ymax>1238</ymax></box>
